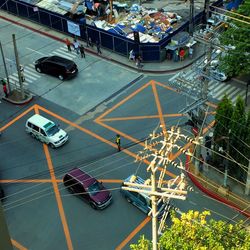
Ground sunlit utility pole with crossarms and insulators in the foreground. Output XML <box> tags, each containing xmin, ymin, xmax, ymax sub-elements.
<box><xmin>122</xmin><ymin>127</ymin><xmax>194</xmax><ymax>250</ymax></box>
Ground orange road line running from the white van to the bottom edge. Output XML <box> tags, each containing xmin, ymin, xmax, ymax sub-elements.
<box><xmin>43</xmin><ymin>144</ymin><xmax>73</xmax><ymax>250</ymax></box>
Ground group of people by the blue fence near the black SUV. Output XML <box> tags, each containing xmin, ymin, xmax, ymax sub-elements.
<box><xmin>65</xmin><ymin>37</ymin><xmax>102</xmax><ymax>58</ymax></box>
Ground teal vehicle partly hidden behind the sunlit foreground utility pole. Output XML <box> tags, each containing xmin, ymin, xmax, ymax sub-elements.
<box><xmin>120</xmin><ymin>175</ymin><xmax>171</xmax><ymax>219</ymax></box>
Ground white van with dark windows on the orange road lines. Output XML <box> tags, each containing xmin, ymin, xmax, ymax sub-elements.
<box><xmin>25</xmin><ymin>114</ymin><xmax>69</xmax><ymax>148</ymax></box>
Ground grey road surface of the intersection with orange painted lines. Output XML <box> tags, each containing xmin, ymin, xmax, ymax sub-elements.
<box><xmin>0</xmin><ymin>18</ymin><xmax>244</xmax><ymax>250</ymax></box>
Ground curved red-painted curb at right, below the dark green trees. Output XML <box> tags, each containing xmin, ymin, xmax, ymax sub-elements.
<box><xmin>185</xmin><ymin>156</ymin><xmax>250</xmax><ymax>217</ymax></box>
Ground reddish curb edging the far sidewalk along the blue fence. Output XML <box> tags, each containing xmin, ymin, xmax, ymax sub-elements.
<box><xmin>0</xmin><ymin>13</ymin><xmax>205</xmax><ymax>74</ymax></box>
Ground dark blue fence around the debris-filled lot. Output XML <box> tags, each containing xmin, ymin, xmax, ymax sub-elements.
<box><xmin>0</xmin><ymin>0</ymin><xmax>223</xmax><ymax>62</ymax></box>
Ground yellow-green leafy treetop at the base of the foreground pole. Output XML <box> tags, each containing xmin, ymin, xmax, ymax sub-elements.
<box><xmin>130</xmin><ymin>211</ymin><xmax>250</xmax><ymax>250</ymax></box>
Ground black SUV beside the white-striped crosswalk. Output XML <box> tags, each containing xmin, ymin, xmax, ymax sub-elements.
<box><xmin>35</xmin><ymin>56</ymin><xmax>78</xmax><ymax>80</ymax></box>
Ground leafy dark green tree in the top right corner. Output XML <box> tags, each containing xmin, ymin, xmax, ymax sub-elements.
<box><xmin>219</xmin><ymin>0</ymin><xmax>250</xmax><ymax>77</ymax></box>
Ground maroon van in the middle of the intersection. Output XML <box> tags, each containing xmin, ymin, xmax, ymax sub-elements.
<box><xmin>63</xmin><ymin>168</ymin><xmax>112</xmax><ymax>209</ymax></box>
